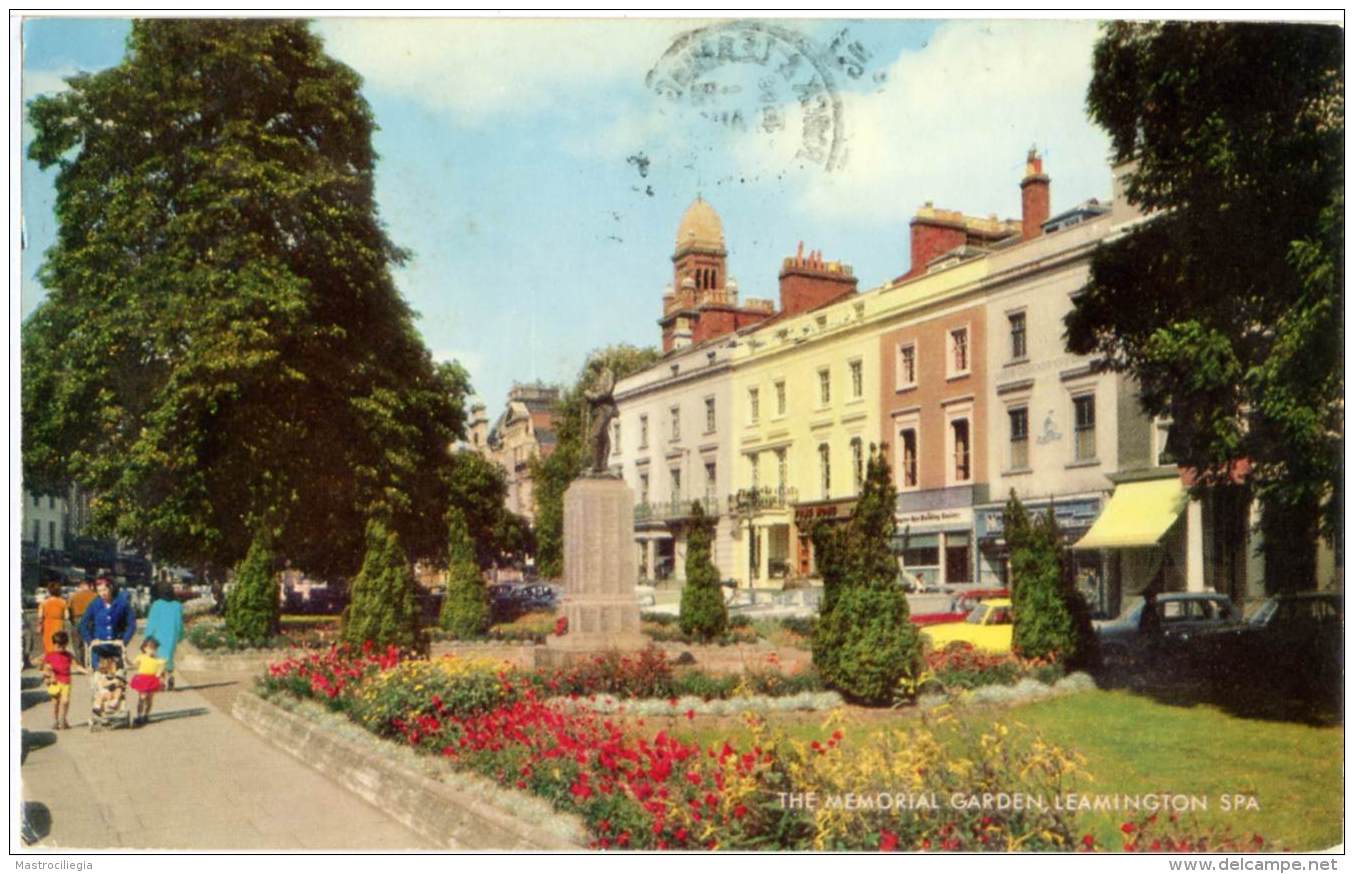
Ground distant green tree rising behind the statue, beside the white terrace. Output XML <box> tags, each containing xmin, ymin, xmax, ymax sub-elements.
<box><xmin>531</xmin><ymin>343</ymin><xmax>661</xmax><ymax>577</ymax></box>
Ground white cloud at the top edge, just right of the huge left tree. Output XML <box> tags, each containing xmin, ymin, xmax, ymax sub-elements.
<box><xmin>308</xmin><ymin>19</ymin><xmax>699</xmax><ymax>123</ymax></box>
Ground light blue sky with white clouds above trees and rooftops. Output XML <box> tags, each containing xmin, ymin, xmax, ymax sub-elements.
<box><xmin>22</xmin><ymin>18</ymin><xmax>1110</xmax><ymax>416</ymax></box>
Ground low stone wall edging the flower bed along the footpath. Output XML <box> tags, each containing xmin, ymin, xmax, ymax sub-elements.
<box><xmin>233</xmin><ymin>692</ymin><xmax>584</xmax><ymax>850</ymax></box>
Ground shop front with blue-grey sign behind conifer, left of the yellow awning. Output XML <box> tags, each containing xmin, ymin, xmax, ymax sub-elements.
<box><xmin>974</xmin><ymin>495</ymin><xmax>1118</xmax><ymax>618</ymax></box>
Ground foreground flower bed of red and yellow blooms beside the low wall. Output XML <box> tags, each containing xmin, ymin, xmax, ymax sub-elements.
<box><xmin>261</xmin><ymin>639</ymin><xmax>1251</xmax><ymax>851</ymax></box>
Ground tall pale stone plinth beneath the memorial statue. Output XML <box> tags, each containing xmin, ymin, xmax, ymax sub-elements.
<box><xmin>540</xmin><ymin>477</ymin><xmax>649</xmax><ymax>664</ymax></box>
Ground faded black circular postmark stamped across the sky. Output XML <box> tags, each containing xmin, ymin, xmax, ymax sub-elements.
<box><xmin>645</xmin><ymin>22</ymin><xmax>869</xmax><ymax>171</ymax></box>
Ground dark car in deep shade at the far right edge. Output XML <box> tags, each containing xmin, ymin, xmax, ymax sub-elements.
<box><xmin>1200</xmin><ymin>592</ymin><xmax>1345</xmax><ymax>696</ymax></box>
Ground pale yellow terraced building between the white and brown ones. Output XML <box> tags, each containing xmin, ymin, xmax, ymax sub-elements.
<box><xmin>733</xmin><ymin>262</ymin><xmax>986</xmax><ymax>587</ymax></box>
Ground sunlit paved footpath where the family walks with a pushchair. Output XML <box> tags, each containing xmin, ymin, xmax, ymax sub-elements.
<box><xmin>20</xmin><ymin>639</ymin><xmax>429</xmax><ymax>851</ymax></box>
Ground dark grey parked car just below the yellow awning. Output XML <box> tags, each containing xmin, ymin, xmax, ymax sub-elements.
<box><xmin>1095</xmin><ymin>592</ymin><xmax>1242</xmax><ymax>669</ymax></box>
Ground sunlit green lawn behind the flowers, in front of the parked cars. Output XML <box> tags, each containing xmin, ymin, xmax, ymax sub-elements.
<box><xmin>673</xmin><ymin>691</ymin><xmax>1345</xmax><ymax>851</ymax></box>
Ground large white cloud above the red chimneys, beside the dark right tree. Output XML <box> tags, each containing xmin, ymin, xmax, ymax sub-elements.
<box><xmin>769</xmin><ymin>20</ymin><xmax>1109</xmax><ymax>222</ymax></box>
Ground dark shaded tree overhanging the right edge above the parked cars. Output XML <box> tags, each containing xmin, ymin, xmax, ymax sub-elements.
<box><xmin>1067</xmin><ymin>22</ymin><xmax>1345</xmax><ymax>589</ymax></box>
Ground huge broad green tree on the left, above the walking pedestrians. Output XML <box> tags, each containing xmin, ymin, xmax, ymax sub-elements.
<box><xmin>22</xmin><ymin>19</ymin><xmax>468</xmax><ymax>573</ymax></box>
